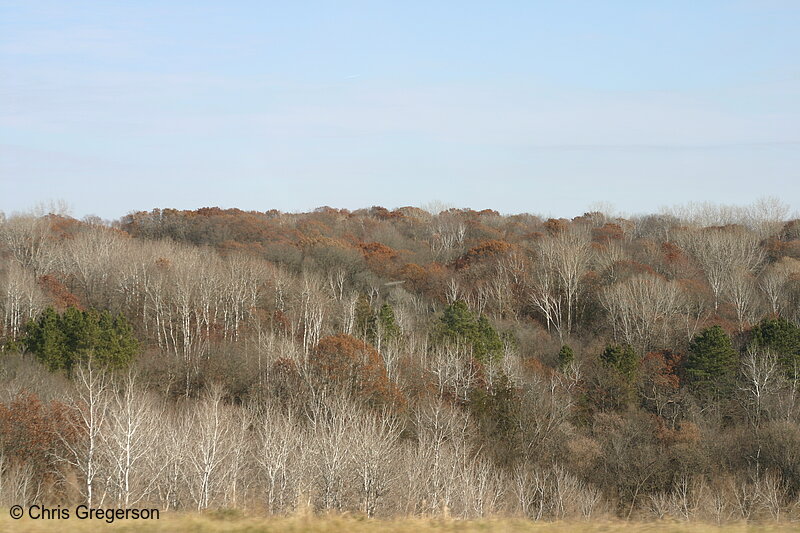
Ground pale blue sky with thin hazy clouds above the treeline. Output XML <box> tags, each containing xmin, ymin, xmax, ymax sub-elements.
<box><xmin>0</xmin><ymin>0</ymin><xmax>800</xmax><ymax>220</ymax></box>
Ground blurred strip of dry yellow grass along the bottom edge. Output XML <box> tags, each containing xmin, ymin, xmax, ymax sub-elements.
<box><xmin>0</xmin><ymin>510</ymin><xmax>800</xmax><ymax>533</ymax></box>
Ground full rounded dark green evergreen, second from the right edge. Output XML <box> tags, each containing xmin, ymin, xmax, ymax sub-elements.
<box><xmin>684</xmin><ymin>326</ymin><xmax>739</xmax><ymax>397</ymax></box>
